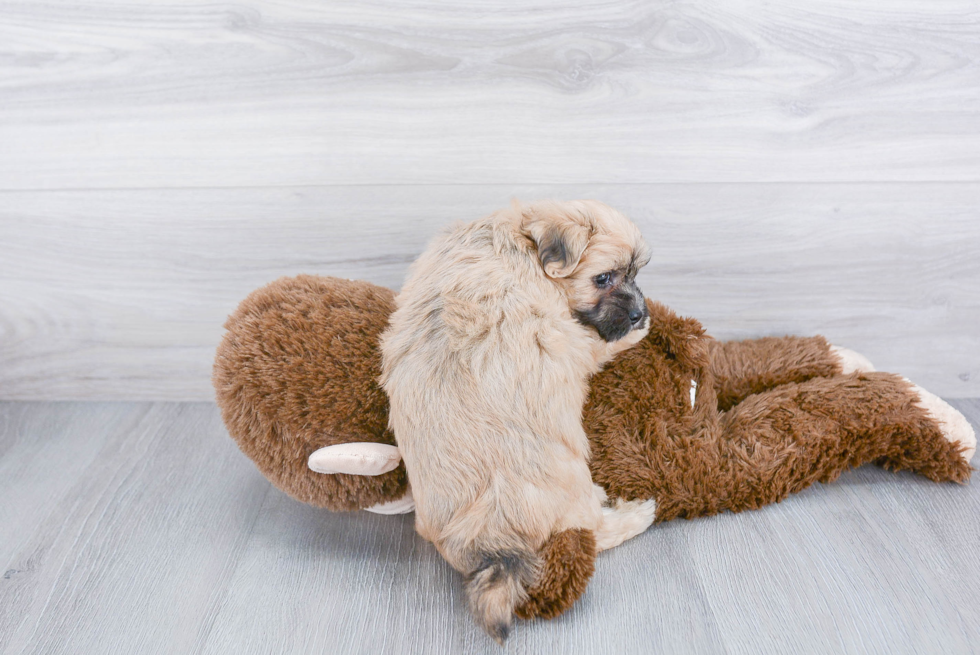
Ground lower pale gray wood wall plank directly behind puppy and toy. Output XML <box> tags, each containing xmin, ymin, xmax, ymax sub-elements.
<box><xmin>0</xmin><ymin>183</ymin><xmax>980</xmax><ymax>400</ymax></box>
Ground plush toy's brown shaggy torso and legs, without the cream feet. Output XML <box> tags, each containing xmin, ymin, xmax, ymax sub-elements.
<box><xmin>584</xmin><ymin>302</ymin><xmax>971</xmax><ymax>521</ymax></box>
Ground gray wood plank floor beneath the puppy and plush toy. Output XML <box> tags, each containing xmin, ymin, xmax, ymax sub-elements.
<box><xmin>0</xmin><ymin>400</ymin><xmax>980</xmax><ymax>654</ymax></box>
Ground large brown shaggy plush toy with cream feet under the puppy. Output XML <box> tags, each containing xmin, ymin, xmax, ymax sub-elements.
<box><xmin>214</xmin><ymin>276</ymin><xmax>976</xmax><ymax>618</ymax></box>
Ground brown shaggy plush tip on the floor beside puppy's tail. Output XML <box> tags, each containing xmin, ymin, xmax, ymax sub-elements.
<box><xmin>516</xmin><ymin>530</ymin><xmax>596</xmax><ymax>619</ymax></box>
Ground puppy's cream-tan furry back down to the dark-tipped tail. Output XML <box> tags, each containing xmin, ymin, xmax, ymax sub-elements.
<box><xmin>382</xmin><ymin>213</ymin><xmax>592</xmax><ymax>640</ymax></box>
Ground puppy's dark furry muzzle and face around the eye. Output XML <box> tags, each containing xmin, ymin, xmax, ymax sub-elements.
<box><xmin>572</xmin><ymin>269</ymin><xmax>649</xmax><ymax>341</ymax></box>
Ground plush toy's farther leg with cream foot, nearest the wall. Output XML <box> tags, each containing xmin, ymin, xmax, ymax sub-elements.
<box><xmin>709</xmin><ymin>336</ymin><xmax>874</xmax><ymax>410</ymax></box>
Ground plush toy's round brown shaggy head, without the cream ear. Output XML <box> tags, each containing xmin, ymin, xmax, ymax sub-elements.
<box><xmin>212</xmin><ymin>275</ymin><xmax>408</xmax><ymax>511</ymax></box>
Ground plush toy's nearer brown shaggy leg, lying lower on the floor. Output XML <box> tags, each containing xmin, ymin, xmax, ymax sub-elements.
<box><xmin>657</xmin><ymin>373</ymin><xmax>975</xmax><ymax>520</ymax></box>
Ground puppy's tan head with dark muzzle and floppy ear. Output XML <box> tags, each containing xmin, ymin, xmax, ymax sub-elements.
<box><xmin>523</xmin><ymin>200</ymin><xmax>650</xmax><ymax>346</ymax></box>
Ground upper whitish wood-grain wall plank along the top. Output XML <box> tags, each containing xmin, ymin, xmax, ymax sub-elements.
<box><xmin>0</xmin><ymin>0</ymin><xmax>980</xmax><ymax>189</ymax></box>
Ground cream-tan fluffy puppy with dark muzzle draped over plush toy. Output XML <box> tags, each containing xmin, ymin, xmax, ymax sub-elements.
<box><xmin>381</xmin><ymin>201</ymin><xmax>654</xmax><ymax>642</ymax></box>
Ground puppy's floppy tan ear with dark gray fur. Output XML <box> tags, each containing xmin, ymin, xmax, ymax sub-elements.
<box><xmin>524</xmin><ymin>205</ymin><xmax>592</xmax><ymax>277</ymax></box>
